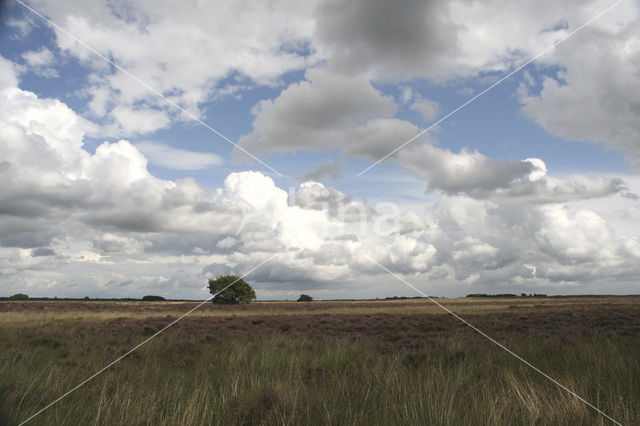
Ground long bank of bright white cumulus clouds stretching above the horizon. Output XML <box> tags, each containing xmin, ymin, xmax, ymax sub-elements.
<box><xmin>0</xmin><ymin>63</ymin><xmax>640</xmax><ymax>297</ymax></box>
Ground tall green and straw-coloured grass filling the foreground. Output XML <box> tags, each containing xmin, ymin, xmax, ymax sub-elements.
<box><xmin>0</xmin><ymin>321</ymin><xmax>640</xmax><ymax>425</ymax></box>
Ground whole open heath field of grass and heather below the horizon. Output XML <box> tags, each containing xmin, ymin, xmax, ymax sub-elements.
<box><xmin>0</xmin><ymin>297</ymin><xmax>640</xmax><ymax>425</ymax></box>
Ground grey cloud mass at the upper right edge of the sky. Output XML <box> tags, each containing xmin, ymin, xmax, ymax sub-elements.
<box><xmin>519</xmin><ymin>2</ymin><xmax>640</xmax><ymax>167</ymax></box>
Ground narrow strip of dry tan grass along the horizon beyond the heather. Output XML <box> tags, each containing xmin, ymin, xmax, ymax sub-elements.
<box><xmin>0</xmin><ymin>297</ymin><xmax>640</xmax><ymax>323</ymax></box>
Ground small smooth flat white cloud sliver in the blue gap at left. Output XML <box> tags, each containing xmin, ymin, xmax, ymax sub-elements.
<box><xmin>135</xmin><ymin>142</ymin><xmax>223</xmax><ymax>170</ymax></box>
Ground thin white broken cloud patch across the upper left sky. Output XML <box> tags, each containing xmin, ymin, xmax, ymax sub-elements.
<box><xmin>31</xmin><ymin>0</ymin><xmax>315</xmax><ymax>136</ymax></box>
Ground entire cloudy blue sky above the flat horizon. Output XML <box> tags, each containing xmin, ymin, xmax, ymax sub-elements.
<box><xmin>0</xmin><ymin>0</ymin><xmax>640</xmax><ymax>299</ymax></box>
